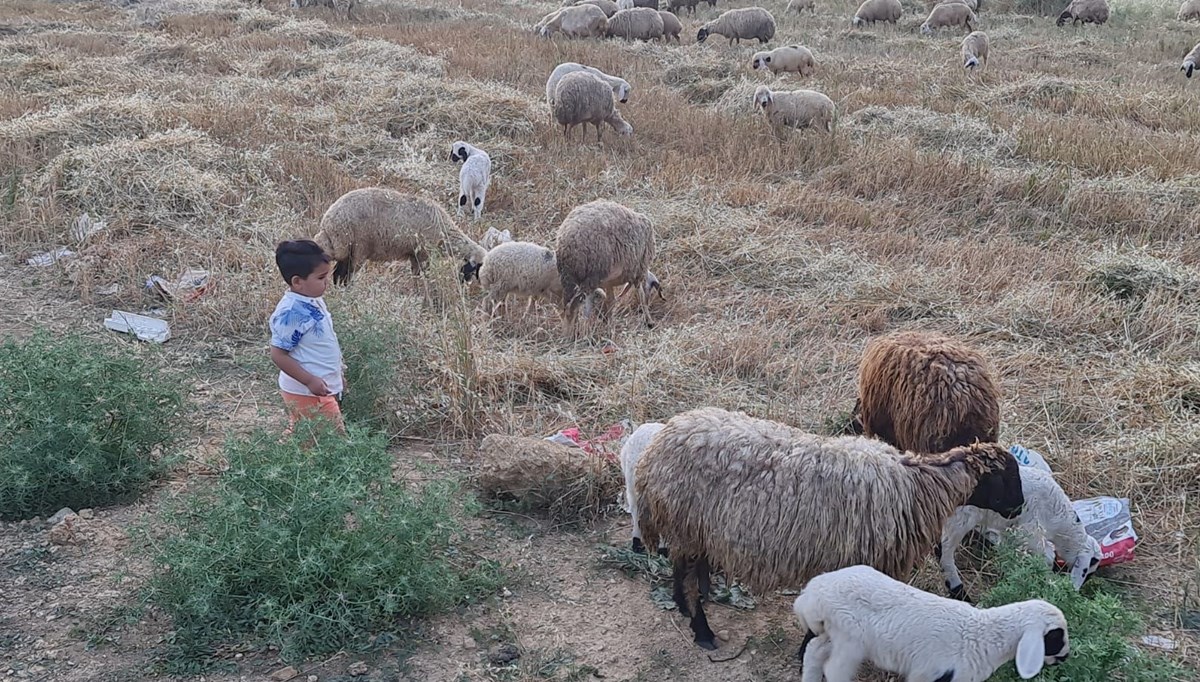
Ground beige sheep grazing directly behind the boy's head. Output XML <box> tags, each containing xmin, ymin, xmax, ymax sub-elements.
<box><xmin>313</xmin><ymin>187</ymin><xmax>486</xmax><ymax>285</ymax></box>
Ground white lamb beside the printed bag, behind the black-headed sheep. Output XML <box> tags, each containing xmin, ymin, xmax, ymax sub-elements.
<box><xmin>936</xmin><ymin>467</ymin><xmax>1104</xmax><ymax>602</ymax></box>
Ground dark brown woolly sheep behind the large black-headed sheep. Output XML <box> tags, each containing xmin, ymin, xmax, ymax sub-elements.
<box><xmin>858</xmin><ymin>331</ymin><xmax>1000</xmax><ymax>453</ymax></box>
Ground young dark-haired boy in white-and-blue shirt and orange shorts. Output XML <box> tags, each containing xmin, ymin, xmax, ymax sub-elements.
<box><xmin>270</xmin><ymin>239</ymin><xmax>346</xmax><ymax>432</ymax></box>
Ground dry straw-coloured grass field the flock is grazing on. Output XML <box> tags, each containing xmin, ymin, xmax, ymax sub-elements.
<box><xmin>0</xmin><ymin>0</ymin><xmax>1200</xmax><ymax>682</ymax></box>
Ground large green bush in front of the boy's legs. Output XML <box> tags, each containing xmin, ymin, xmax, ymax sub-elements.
<box><xmin>149</xmin><ymin>420</ymin><xmax>502</xmax><ymax>668</ymax></box>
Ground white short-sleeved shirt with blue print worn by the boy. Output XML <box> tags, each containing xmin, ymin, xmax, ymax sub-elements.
<box><xmin>270</xmin><ymin>291</ymin><xmax>342</xmax><ymax>395</ymax></box>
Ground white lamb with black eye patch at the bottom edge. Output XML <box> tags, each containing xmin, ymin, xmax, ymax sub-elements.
<box><xmin>792</xmin><ymin>566</ymin><xmax>1070</xmax><ymax>682</ymax></box>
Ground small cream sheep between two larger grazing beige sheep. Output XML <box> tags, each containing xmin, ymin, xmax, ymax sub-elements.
<box><xmin>479</xmin><ymin>241</ymin><xmax>563</xmax><ymax>315</ymax></box>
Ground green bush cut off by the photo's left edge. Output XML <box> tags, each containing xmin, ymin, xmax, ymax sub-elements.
<box><xmin>0</xmin><ymin>331</ymin><xmax>181</xmax><ymax>520</ymax></box>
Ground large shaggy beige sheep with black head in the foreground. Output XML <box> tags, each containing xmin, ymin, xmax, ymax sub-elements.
<box><xmin>638</xmin><ymin>408</ymin><xmax>1025</xmax><ymax>650</ymax></box>
